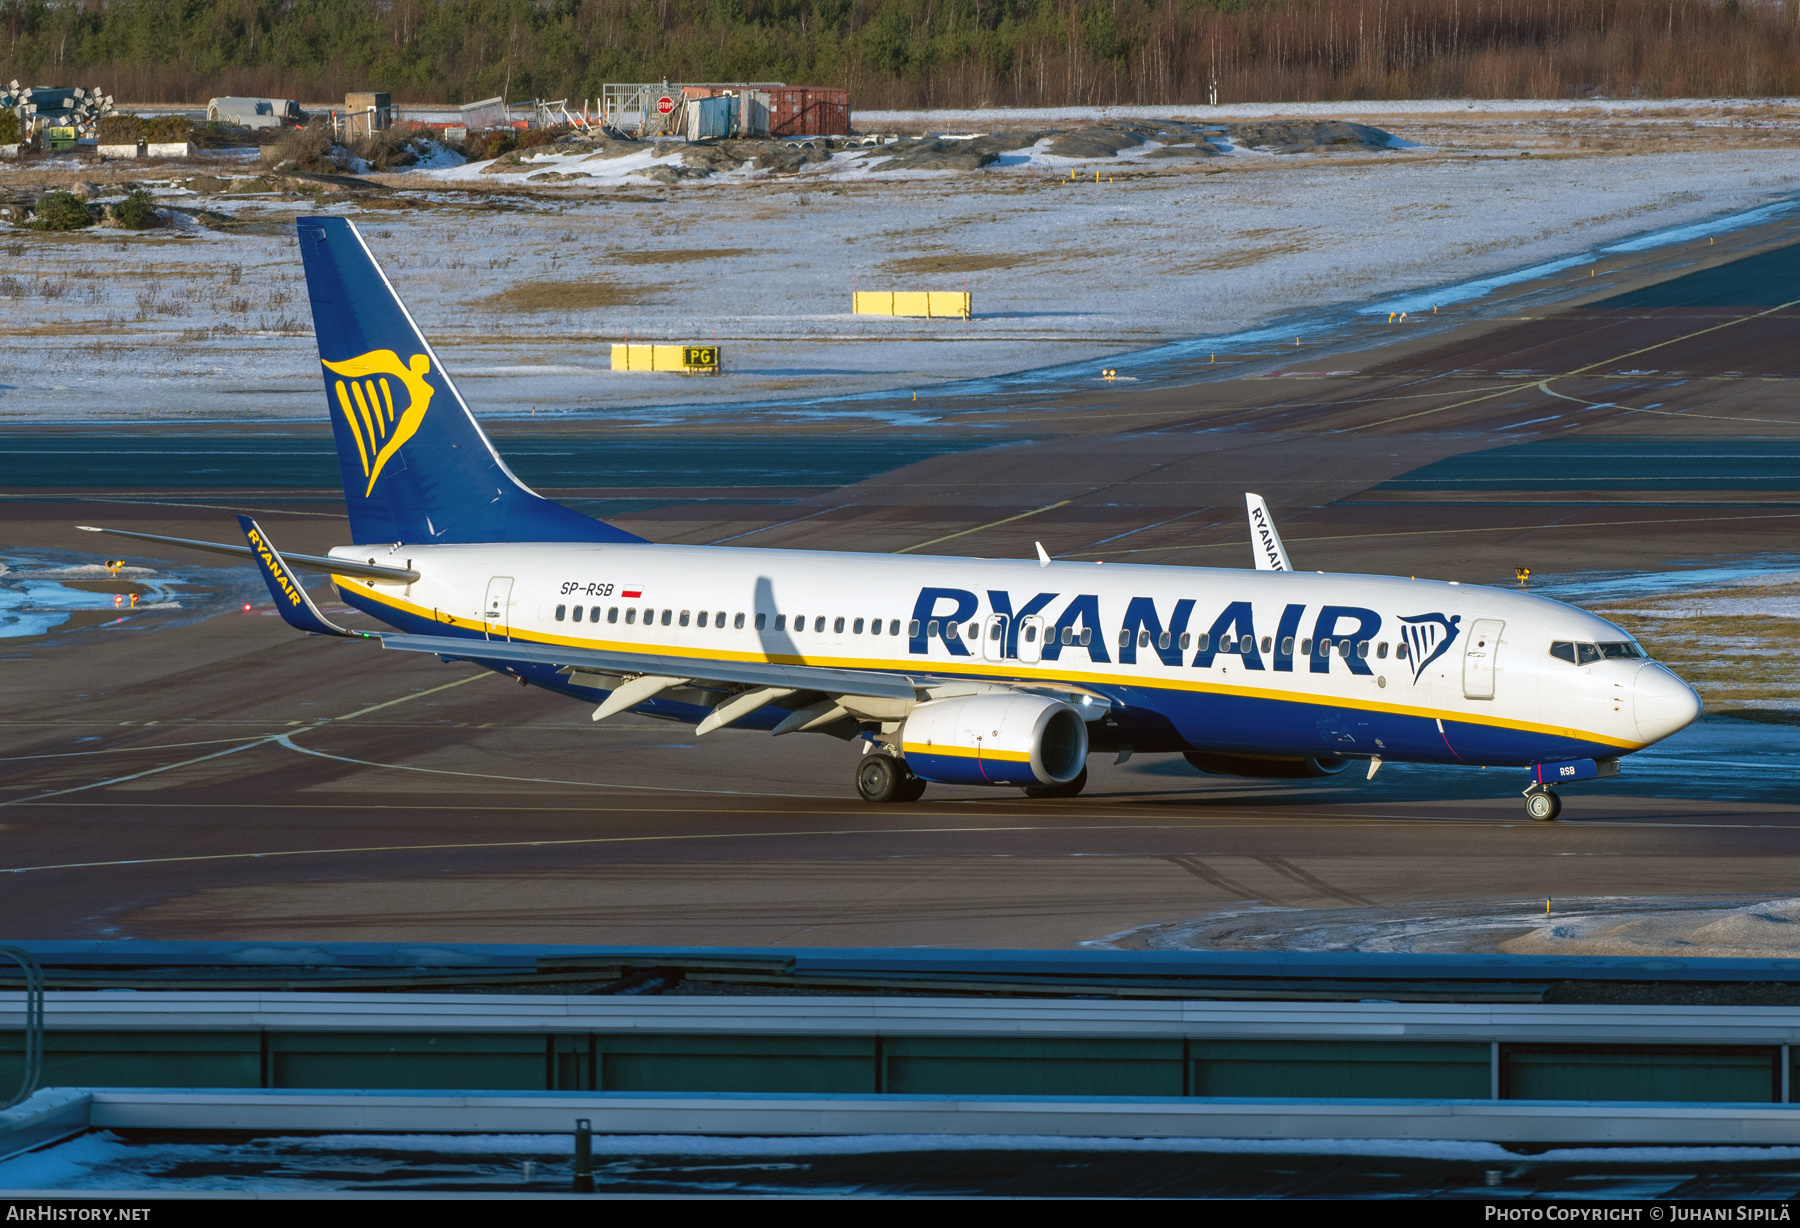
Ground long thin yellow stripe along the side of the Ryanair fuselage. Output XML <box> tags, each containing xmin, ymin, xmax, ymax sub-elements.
<box><xmin>331</xmin><ymin>576</ymin><xmax>1649</xmax><ymax>751</ymax></box>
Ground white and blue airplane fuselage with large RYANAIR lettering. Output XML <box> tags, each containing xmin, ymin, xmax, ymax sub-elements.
<box><xmin>331</xmin><ymin>544</ymin><xmax>1699</xmax><ymax>765</ymax></box>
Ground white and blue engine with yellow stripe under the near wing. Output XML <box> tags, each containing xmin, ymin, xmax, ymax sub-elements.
<box><xmin>900</xmin><ymin>693</ymin><xmax>1087</xmax><ymax>785</ymax></box>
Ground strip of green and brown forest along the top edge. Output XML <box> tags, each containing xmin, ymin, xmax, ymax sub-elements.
<box><xmin>10</xmin><ymin>0</ymin><xmax>1800</xmax><ymax>110</ymax></box>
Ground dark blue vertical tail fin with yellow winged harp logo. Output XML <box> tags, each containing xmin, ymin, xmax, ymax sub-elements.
<box><xmin>297</xmin><ymin>218</ymin><xmax>644</xmax><ymax>544</ymax></box>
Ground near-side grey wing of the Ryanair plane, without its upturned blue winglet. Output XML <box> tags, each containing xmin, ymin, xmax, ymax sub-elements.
<box><xmin>382</xmin><ymin>634</ymin><xmax>918</xmax><ymax>699</ymax></box>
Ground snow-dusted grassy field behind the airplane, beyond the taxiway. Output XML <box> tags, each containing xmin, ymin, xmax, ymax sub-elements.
<box><xmin>0</xmin><ymin>104</ymin><xmax>1800</xmax><ymax>423</ymax></box>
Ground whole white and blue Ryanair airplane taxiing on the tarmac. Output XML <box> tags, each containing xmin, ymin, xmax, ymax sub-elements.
<box><xmin>83</xmin><ymin>218</ymin><xmax>1701</xmax><ymax>819</ymax></box>
